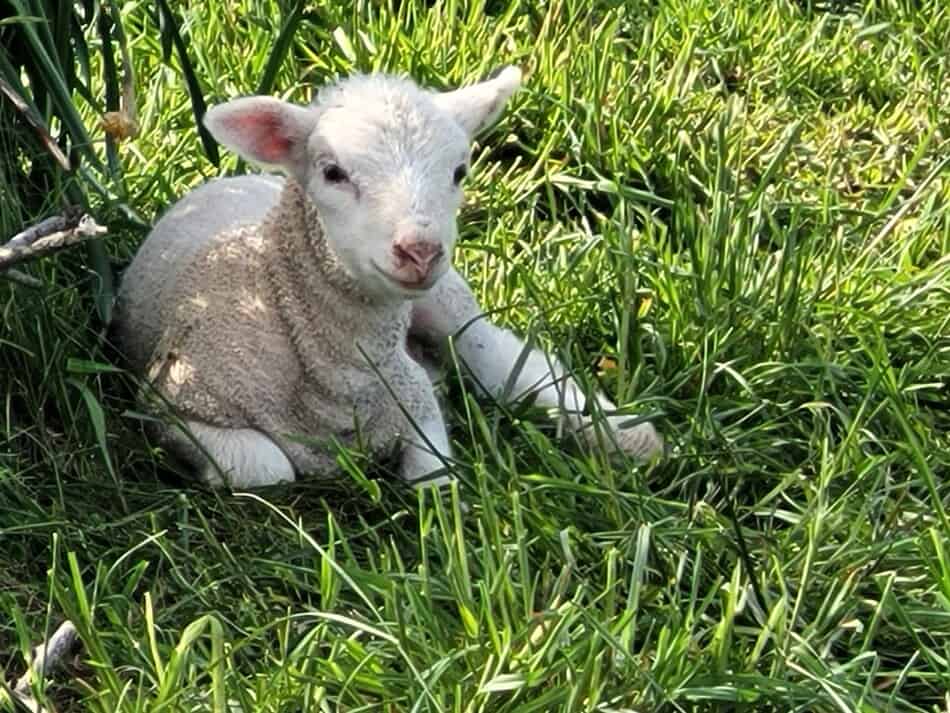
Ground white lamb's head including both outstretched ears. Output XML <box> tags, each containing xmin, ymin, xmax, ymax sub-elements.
<box><xmin>205</xmin><ymin>67</ymin><xmax>521</xmax><ymax>297</ymax></box>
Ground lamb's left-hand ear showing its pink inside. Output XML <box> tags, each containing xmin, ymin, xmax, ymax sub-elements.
<box><xmin>204</xmin><ymin>97</ymin><xmax>317</xmax><ymax>169</ymax></box>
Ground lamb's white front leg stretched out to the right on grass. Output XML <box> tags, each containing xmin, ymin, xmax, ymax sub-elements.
<box><xmin>411</xmin><ymin>270</ymin><xmax>663</xmax><ymax>460</ymax></box>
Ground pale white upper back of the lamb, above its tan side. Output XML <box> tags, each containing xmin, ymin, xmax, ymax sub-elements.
<box><xmin>115</xmin><ymin>175</ymin><xmax>283</xmax><ymax>371</ymax></box>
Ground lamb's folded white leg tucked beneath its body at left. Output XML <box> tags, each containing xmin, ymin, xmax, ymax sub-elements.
<box><xmin>156</xmin><ymin>421</ymin><xmax>295</xmax><ymax>489</ymax></box>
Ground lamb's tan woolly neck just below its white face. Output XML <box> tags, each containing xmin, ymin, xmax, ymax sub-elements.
<box><xmin>263</xmin><ymin>179</ymin><xmax>410</xmax><ymax>363</ymax></box>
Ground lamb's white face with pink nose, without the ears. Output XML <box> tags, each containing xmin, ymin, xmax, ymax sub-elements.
<box><xmin>306</xmin><ymin>77</ymin><xmax>469</xmax><ymax>298</ymax></box>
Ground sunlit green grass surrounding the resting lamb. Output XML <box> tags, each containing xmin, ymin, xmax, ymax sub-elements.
<box><xmin>0</xmin><ymin>0</ymin><xmax>950</xmax><ymax>713</ymax></box>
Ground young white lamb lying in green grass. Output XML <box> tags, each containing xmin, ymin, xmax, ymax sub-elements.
<box><xmin>116</xmin><ymin>67</ymin><xmax>662</xmax><ymax>488</ymax></box>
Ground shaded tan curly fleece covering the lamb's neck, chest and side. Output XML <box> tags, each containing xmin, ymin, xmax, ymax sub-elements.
<box><xmin>118</xmin><ymin>179</ymin><xmax>431</xmax><ymax>475</ymax></box>
